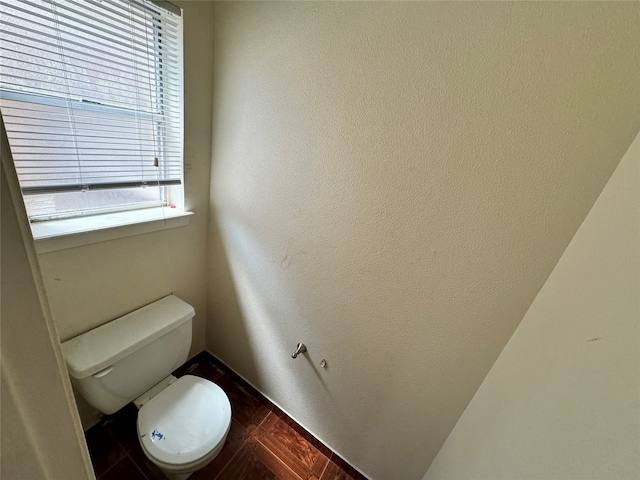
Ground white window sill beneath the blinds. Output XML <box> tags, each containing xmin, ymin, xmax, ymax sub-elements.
<box><xmin>31</xmin><ymin>207</ymin><xmax>193</xmax><ymax>253</ymax></box>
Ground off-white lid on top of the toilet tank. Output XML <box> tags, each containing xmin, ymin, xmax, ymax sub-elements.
<box><xmin>62</xmin><ymin>295</ymin><xmax>195</xmax><ymax>379</ymax></box>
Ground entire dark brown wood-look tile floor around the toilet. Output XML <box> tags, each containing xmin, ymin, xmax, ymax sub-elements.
<box><xmin>86</xmin><ymin>352</ymin><xmax>366</xmax><ymax>480</ymax></box>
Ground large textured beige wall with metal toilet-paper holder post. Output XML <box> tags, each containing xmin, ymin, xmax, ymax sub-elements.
<box><xmin>206</xmin><ymin>2</ymin><xmax>640</xmax><ymax>480</ymax></box>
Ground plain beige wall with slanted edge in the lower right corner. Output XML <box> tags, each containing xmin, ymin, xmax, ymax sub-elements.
<box><xmin>424</xmin><ymin>129</ymin><xmax>640</xmax><ymax>480</ymax></box>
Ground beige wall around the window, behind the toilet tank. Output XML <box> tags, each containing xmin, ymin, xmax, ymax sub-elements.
<box><xmin>39</xmin><ymin>2</ymin><xmax>213</xmax><ymax>353</ymax></box>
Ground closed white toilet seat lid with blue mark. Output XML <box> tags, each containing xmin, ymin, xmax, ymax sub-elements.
<box><xmin>137</xmin><ymin>375</ymin><xmax>231</xmax><ymax>465</ymax></box>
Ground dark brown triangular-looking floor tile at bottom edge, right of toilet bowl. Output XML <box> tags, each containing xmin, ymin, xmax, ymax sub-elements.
<box><xmin>216</xmin><ymin>443</ymin><xmax>300</xmax><ymax>480</ymax></box>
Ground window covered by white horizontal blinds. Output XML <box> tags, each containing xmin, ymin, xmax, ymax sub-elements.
<box><xmin>0</xmin><ymin>0</ymin><xmax>183</xmax><ymax>221</ymax></box>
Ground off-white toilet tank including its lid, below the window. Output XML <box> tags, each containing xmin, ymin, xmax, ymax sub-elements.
<box><xmin>62</xmin><ymin>295</ymin><xmax>195</xmax><ymax>414</ymax></box>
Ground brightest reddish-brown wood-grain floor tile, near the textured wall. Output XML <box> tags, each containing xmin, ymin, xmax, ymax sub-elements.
<box><xmin>257</xmin><ymin>412</ymin><xmax>329</xmax><ymax>479</ymax></box>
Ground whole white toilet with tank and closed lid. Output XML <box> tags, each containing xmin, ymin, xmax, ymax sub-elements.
<box><xmin>62</xmin><ymin>295</ymin><xmax>231</xmax><ymax>480</ymax></box>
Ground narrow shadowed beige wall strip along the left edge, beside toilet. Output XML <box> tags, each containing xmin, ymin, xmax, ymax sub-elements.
<box><xmin>0</xmin><ymin>121</ymin><xmax>95</xmax><ymax>480</ymax></box>
